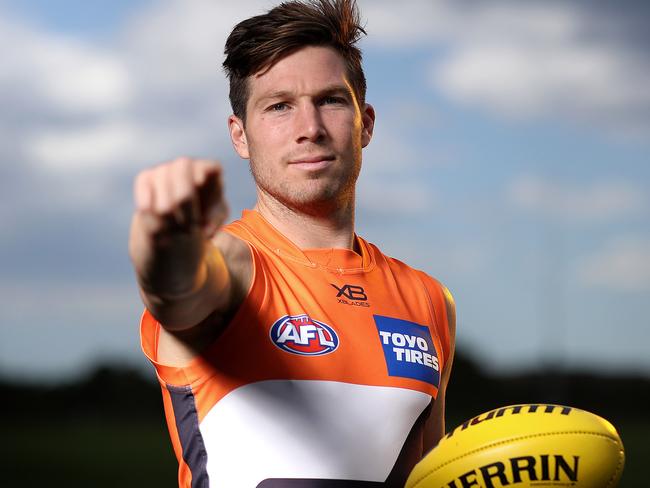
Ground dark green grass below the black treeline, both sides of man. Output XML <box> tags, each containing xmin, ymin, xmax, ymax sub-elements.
<box><xmin>0</xmin><ymin>417</ymin><xmax>650</xmax><ymax>488</ymax></box>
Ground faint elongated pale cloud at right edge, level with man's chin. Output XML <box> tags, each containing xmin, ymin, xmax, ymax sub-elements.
<box><xmin>507</xmin><ymin>176</ymin><xmax>648</xmax><ymax>221</ymax></box>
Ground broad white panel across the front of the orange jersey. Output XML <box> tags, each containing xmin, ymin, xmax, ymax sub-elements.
<box><xmin>200</xmin><ymin>380</ymin><xmax>431</xmax><ymax>488</ymax></box>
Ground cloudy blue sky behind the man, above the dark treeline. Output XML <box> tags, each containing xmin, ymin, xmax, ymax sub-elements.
<box><xmin>0</xmin><ymin>0</ymin><xmax>650</xmax><ymax>379</ymax></box>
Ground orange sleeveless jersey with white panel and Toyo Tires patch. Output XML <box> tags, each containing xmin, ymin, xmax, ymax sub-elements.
<box><xmin>141</xmin><ymin>211</ymin><xmax>450</xmax><ymax>488</ymax></box>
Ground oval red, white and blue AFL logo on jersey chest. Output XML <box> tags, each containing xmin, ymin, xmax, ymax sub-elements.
<box><xmin>270</xmin><ymin>314</ymin><xmax>339</xmax><ymax>356</ymax></box>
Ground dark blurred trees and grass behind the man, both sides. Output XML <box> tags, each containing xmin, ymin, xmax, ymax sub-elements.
<box><xmin>5</xmin><ymin>355</ymin><xmax>650</xmax><ymax>488</ymax></box>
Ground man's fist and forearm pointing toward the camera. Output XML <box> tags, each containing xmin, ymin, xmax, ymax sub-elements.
<box><xmin>129</xmin><ymin>158</ymin><xmax>233</xmax><ymax>332</ymax></box>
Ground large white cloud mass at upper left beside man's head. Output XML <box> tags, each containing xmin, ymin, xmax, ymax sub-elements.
<box><xmin>0</xmin><ymin>0</ymin><xmax>264</xmax><ymax>178</ymax></box>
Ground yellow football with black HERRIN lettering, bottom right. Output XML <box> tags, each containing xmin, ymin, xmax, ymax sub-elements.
<box><xmin>406</xmin><ymin>404</ymin><xmax>625</xmax><ymax>488</ymax></box>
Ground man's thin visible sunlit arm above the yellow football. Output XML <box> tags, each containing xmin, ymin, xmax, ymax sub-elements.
<box><xmin>424</xmin><ymin>287</ymin><xmax>456</xmax><ymax>452</ymax></box>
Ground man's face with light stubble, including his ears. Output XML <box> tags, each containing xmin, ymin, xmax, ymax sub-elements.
<box><xmin>229</xmin><ymin>47</ymin><xmax>374</xmax><ymax>213</ymax></box>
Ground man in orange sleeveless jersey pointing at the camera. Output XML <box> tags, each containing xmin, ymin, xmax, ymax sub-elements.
<box><xmin>129</xmin><ymin>0</ymin><xmax>455</xmax><ymax>488</ymax></box>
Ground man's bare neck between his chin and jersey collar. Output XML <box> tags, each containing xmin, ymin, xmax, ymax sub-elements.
<box><xmin>255</xmin><ymin>192</ymin><xmax>354</xmax><ymax>249</ymax></box>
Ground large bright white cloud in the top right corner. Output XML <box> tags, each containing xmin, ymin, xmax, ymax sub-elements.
<box><xmin>422</xmin><ymin>2</ymin><xmax>650</xmax><ymax>134</ymax></box>
